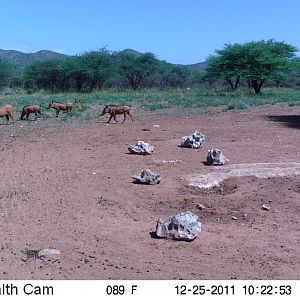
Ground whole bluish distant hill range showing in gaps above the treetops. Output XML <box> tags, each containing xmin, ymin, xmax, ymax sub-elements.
<box><xmin>0</xmin><ymin>49</ymin><xmax>206</xmax><ymax>71</ymax></box>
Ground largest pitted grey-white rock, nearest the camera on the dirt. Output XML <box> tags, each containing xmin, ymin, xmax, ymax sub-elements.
<box><xmin>156</xmin><ymin>211</ymin><xmax>201</xmax><ymax>241</ymax></box>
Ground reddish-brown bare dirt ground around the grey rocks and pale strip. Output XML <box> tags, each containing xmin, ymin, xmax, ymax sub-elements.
<box><xmin>0</xmin><ymin>106</ymin><xmax>300</xmax><ymax>279</ymax></box>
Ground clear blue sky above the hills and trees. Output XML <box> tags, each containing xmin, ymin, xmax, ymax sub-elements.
<box><xmin>0</xmin><ymin>0</ymin><xmax>300</xmax><ymax>64</ymax></box>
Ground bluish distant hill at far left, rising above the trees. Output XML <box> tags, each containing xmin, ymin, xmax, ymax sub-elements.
<box><xmin>0</xmin><ymin>49</ymin><xmax>66</xmax><ymax>69</ymax></box>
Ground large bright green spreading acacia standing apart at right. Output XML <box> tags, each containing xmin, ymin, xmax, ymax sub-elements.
<box><xmin>207</xmin><ymin>40</ymin><xmax>297</xmax><ymax>94</ymax></box>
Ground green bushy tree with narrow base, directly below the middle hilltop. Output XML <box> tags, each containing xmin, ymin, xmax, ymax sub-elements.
<box><xmin>117</xmin><ymin>53</ymin><xmax>159</xmax><ymax>89</ymax></box>
